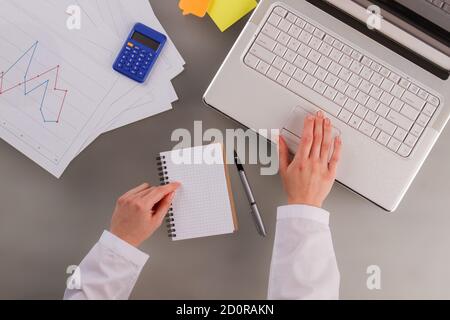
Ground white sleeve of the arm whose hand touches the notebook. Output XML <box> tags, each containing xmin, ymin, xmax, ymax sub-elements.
<box><xmin>64</xmin><ymin>231</ymin><xmax>148</xmax><ymax>300</ymax></box>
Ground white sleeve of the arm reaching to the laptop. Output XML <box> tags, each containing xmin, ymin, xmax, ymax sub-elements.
<box><xmin>268</xmin><ymin>205</ymin><xmax>340</xmax><ymax>299</ymax></box>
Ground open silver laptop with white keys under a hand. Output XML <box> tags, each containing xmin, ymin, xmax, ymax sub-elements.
<box><xmin>203</xmin><ymin>0</ymin><xmax>450</xmax><ymax>212</ymax></box>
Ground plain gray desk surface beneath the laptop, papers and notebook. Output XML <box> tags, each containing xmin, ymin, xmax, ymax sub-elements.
<box><xmin>0</xmin><ymin>0</ymin><xmax>450</xmax><ymax>299</ymax></box>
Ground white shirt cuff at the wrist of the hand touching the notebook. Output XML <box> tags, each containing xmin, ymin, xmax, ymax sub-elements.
<box><xmin>99</xmin><ymin>230</ymin><xmax>149</xmax><ymax>267</ymax></box>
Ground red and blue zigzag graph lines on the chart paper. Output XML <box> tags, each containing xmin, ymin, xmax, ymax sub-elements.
<box><xmin>0</xmin><ymin>41</ymin><xmax>69</xmax><ymax>123</ymax></box>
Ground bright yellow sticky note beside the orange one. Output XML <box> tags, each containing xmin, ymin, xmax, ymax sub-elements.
<box><xmin>208</xmin><ymin>0</ymin><xmax>257</xmax><ymax>32</ymax></box>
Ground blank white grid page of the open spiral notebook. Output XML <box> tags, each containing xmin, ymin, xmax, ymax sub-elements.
<box><xmin>161</xmin><ymin>144</ymin><xmax>235</xmax><ymax>240</ymax></box>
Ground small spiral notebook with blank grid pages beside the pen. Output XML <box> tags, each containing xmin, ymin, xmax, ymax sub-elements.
<box><xmin>158</xmin><ymin>144</ymin><xmax>237</xmax><ymax>241</ymax></box>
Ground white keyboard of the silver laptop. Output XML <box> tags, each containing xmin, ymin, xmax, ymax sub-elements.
<box><xmin>244</xmin><ymin>6</ymin><xmax>440</xmax><ymax>157</ymax></box>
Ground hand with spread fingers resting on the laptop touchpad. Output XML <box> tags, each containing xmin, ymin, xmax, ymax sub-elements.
<box><xmin>280</xmin><ymin>111</ymin><xmax>342</xmax><ymax>208</ymax></box>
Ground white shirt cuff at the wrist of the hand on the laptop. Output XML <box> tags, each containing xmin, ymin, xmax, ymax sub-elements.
<box><xmin>277</xmin><ymin>204</ymin><xmax>330</xmax><ymax>226</ymax></box>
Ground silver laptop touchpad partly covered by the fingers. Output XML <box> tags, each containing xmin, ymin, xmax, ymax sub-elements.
<box><xmin>281</xmin><ymin>106</ymin><xmax>341</xmax><ymax>154</ymax></box>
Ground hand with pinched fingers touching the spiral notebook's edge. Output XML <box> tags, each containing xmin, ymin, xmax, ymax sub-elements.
<box><xmin>110</xmin><ymin>183</ymin><xmax>180</xmax><ymax>247</ymax></box>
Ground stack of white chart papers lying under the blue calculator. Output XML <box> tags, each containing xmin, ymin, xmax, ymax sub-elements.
<box><xmin>0</xmin><ymin>0</ymin><xmax>185</xmax><ymax>178</ymax></box>
